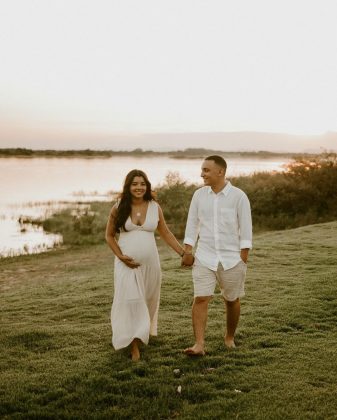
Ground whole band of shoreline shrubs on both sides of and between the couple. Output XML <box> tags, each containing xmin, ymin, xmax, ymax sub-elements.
<box><xmin>43</xmin><ymin>154</ymin><xmax>337</xmax><ymax>245</ymax></box>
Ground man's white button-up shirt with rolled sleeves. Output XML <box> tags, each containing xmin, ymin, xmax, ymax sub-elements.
<box><xmin>184</xmin><ymin>181</ymin><xmax>252</xmax><ymax>270</ymax></box>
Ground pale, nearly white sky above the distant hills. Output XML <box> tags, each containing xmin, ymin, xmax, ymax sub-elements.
<box><xmin>0</xmin><ymin>0</ymin><xmax>337</xmax><ymax>149</ymax></box>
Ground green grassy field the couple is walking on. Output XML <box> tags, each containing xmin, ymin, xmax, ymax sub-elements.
<box><xmin>0</xmin><ymin>222</ymin><xmax>337</xmax><ymax>419</ymax></box>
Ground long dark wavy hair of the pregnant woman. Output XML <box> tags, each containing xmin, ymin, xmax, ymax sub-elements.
<box><xmin>115</xmin><ymin>169</ymin><xmax>154</xmax><ymax>232</ymax></box>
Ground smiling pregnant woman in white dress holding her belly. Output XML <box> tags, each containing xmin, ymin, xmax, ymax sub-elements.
<box><xmin>106</xmin><ymin>169</ymin><xmax>184</xmax><ymax>361</ymax></box>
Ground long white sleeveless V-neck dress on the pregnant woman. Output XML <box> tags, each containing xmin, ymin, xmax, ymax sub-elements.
<box><xmin>111</xmin><ymin>201</ymin><xmax>161</xmax><ymax>350</ymax></box>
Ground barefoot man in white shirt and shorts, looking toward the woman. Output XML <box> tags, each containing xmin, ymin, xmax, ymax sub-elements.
<box><xmin>182</xmin><ymin>155</ymin><xmax>252</xmax><ymax>356</ymax></box>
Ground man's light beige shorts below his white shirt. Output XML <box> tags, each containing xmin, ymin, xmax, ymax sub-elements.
<box><xmin>192</xmin><ymin>259</ymin><xmax>247</xmax><ymax>302</ymax></box>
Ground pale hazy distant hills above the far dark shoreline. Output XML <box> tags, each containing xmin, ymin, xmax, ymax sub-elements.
<box><xmin>0</xmin><ymin>131</ymin><xmax>337</xmax><ymax>153</ymax></box>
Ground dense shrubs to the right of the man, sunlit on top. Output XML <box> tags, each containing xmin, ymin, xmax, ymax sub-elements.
<box><xmin>233</xmin><ymin>154</ymin><xmax>337</xmax><ymax>230</ymax></box>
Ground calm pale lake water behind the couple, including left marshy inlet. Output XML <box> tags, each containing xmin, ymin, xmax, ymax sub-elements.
<box><xmin>0</xmin><ymin>157</ymin><xmax>288</xmax><ymax>256</ymax></box>
